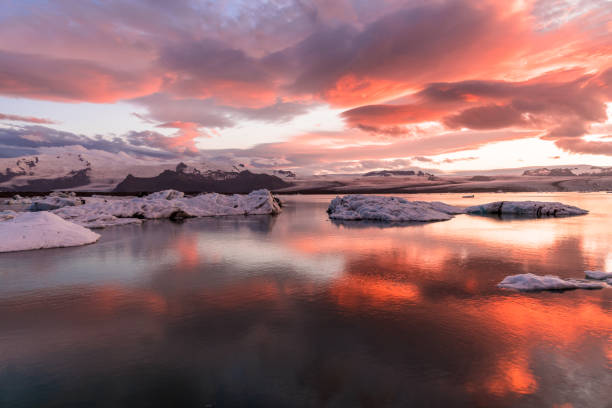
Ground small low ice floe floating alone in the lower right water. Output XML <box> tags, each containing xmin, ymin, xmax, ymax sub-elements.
<box><xmin>497</xmin><ymin>273</ymin><xmax>605</xmax><ymax>291</ymax></box>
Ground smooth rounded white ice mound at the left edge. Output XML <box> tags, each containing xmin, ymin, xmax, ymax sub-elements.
<box><xmin>0</xmin><ymin>211</ymin><xmax>100</xmax><ymax>252</ymax></box>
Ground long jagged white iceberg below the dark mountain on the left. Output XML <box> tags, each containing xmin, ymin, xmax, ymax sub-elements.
<box><xmin>53</xmin><ymin>190</ymin><xmax>281</xmax><ymax>228</ymax></box>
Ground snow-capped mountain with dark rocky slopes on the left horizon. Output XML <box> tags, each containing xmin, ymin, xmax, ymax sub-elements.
<box><xmin>0</xmin><ymin>147</ymin><xmax>295</xmax><ymax>193</ymax></box>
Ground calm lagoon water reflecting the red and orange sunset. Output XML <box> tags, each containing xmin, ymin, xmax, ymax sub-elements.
<box><xmin>0</xmin><ymin>193</ymin><xmax>612</xmax><ymax>408</ymax></box>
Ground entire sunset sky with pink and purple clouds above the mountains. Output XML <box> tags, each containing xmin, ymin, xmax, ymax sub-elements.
<box><xmin>0</xmin><ymin>0</ymin><xmax>612</xmax><ymax>174</ymax></box>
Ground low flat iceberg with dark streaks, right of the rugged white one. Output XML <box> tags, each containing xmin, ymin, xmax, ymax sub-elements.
<box><xmin>465</xmin><ymin>201</ymin><xmax>588</xmax><ymax>218</ymax></box>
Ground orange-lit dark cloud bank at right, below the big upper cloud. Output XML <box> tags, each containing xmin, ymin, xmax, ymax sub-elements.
<box><xmin>342</xmin><ymin>68</ymin><xmax>612</xmax><ymax>154</ymax></box>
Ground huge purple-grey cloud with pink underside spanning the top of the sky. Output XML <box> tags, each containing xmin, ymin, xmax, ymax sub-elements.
<box><xmin>0</xmin><ymin>0</ymin><xmax>610</xmax><ymax>108</ymax></box>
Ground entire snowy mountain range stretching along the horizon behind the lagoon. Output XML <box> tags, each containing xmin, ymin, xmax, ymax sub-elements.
<box><xmin>0</xmin><ymin>146</ymin><xmax>612</xmax><ymax>194</ymax></box>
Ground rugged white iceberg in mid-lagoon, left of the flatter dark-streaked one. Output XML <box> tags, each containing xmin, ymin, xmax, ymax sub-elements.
<box><xmin>327</xmin><ymin>194</ymin><xmax>463</xmax><ymax>222</ymax></box>
